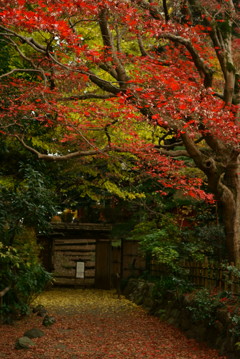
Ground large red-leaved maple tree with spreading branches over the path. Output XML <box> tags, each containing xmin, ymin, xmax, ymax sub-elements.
<box><xmin>0</xmin><ymin>0</ymin><xmax>240</xmax><ymax>263</ymax></box>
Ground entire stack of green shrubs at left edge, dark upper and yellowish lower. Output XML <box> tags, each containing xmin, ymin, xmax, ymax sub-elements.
<box><xmin>0</xmin><ymin>165</ymin><xmax>56</xmax><ymax>320</ymax></box>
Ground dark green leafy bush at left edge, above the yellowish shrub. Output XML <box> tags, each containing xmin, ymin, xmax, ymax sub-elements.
<box><xmin>0</xmin><ymin>165</ymin><xmax>56</xmax><ymax>245</ymax></box>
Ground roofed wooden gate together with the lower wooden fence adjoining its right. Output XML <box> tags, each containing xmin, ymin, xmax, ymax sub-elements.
<box><xmin>39</xmin><ymin>223</ymin><xmax>146</xmax><ymax>289</ymax></box>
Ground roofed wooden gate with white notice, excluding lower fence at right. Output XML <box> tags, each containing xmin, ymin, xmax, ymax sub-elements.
<box><xmin>39</xmin><ymin>223</ymin><xmax>112</xmax><ymax>289</ymax></box>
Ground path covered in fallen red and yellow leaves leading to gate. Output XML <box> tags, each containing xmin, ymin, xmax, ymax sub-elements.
<box><xmin>0</xmin><ymin>289</ymin><xmax>226</xmax><ymax>359</ymax></box>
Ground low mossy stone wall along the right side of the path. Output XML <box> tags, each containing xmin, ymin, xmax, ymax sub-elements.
<box><xmin>123</xmin><ymin>279</ymin><xmax>240</xmax><ymax>359</ymax></box>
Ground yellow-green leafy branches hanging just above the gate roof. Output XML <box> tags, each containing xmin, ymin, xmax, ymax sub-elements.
<box><xmin>58</xmin><ymin>154</ymin><xmax>145</xmax><ymax>208</ymax></box>
